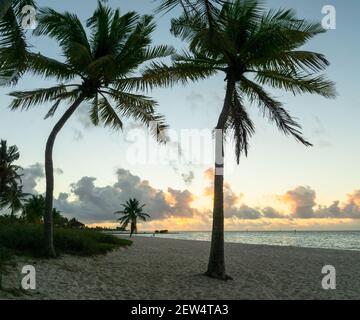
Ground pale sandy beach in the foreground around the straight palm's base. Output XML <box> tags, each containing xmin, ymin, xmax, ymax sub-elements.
<box><xmin>0</xmin><ymin>237</ymin><xmax>360</xmax><ymax>299</ymax></box>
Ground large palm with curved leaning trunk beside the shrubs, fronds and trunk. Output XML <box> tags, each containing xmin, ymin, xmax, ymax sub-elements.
<box><xmin>10</xmin><ymin>2</ymin><xmax>174</xmax><ymax>256</ymax></box>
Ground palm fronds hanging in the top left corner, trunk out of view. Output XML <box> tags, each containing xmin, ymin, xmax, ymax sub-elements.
<box><xmin>0</xmin><ymin>0</ymin><xmax>36</xmax><ymax>85</ymax></box>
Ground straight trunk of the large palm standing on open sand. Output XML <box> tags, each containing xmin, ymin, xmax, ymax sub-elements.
<box><xmin>205</xmin><ymin>78</ymin><xmax>235</xmax><ymax>280</ymax></box>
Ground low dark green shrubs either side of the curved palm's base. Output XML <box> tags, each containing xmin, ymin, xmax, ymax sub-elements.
<box><xmin>0</xmin><ymin>223</ymin><xmax>131</xmax><ymax>256</ymax></box>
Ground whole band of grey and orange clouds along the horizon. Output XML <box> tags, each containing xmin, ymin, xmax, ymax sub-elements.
<box><xmin>23</xmin><ymin>163</ymin><xmax>360</xmax><ymax>228</ymax></box>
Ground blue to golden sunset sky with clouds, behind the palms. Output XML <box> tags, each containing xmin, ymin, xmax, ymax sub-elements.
<box><xmin>0</xmin><ymin>0</ymin><xmax>360</xmax><ymax>230</ymax></box>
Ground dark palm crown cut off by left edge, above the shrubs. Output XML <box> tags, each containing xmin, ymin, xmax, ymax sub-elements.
<box><xmin>0</xmin><ymin>140</ymin><xmax>22</xmax><ymax>198</ymax></box>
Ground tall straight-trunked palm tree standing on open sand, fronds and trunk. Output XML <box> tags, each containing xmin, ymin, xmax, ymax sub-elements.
<box><xmin>158</xmin><ymin>0</ymin><xmax>336</xmax><ymax>279</ymax></box>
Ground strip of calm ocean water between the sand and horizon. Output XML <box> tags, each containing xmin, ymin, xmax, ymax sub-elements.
<box><xmin>134</xmin><ymin>231</ymin><xmax>360</xmax><ymax>251</ymax></box>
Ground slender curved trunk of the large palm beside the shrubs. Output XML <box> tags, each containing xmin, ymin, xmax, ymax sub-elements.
<box><xmin>44</xmin><ymin>96</ymin><xmax>84</xmax><ymax>257</ymax></box>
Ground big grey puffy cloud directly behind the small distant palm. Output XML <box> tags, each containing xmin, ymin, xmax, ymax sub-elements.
<box><xmin>54</xmin><ymin>169</ymin><xmax>197</xmax><ymax>223</ymax></box>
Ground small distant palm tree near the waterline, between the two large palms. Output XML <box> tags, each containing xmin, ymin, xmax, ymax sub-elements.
<box><xmin>114</xmin><ymin>198</ymin><xmax>150</xmax><ymax>237</ymax></box>
